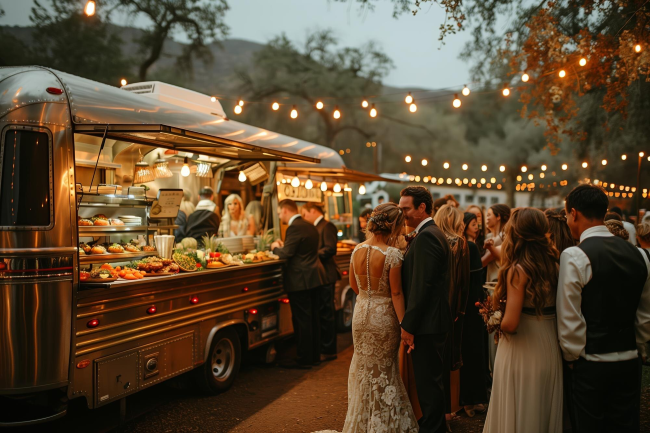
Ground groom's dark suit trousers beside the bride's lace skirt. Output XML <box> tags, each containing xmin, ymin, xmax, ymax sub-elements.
<box><xmin>411</xmin><ymin>333</ymin><xmax>447</xmax><ymax>433</ymax></box>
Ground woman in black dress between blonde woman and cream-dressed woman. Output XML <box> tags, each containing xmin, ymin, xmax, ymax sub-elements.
<box><xmin>460</xmin><ymin>212</ymin><xmax>488</xmax><ymax>416</ymax></box>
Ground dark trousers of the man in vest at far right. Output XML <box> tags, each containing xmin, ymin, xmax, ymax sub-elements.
<box><xmin>568</xmin><ymin>356</ymin><xmax>641</xmax><ymax>433</ymax></box>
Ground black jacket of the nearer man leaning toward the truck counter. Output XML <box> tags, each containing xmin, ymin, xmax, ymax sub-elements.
<box><xmin>273</xmin><ymin>217</ymin><xmax>325</xmax><ymax>292</ymax></box>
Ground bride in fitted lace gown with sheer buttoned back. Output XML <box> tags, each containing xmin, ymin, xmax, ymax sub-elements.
<box><xmin>319</xmin><ymin>203</ymin><xmax>418</xmax><ymax>433</ymax></box>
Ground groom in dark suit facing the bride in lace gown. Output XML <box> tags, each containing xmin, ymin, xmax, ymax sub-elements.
<box><xmin>399</xmin><ymin>186</ymin><xmax>452</xmax><ymax>433</ymax></box>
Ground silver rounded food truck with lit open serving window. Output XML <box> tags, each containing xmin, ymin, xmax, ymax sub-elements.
<box><xmin>0</xmin><ymin>67</ymin><xmax>330</xmax><ymax>426</ymax></box>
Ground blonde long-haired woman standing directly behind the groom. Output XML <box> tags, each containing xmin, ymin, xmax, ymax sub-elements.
<box><xmin>433</xmin><ymin>204</ymin><xmax>469</xmax><ymax>420</ymax></box>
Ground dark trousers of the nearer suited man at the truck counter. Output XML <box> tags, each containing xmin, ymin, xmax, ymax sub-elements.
<box><xmin>289</xmin><ymin>287</ymin><xmax>321</xmax><ymax>365</ymax></box>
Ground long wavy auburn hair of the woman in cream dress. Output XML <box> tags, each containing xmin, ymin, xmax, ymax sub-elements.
<box><xmin>493</xmin><ymin>207</ymin><xmax>560</xmax><ymax>316</ymax></box>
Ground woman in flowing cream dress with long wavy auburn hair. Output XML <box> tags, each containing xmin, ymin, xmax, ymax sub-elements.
<box><xmin>483</xmin><ymin>208</ymin><xmax>562</xmax><ymax>433</ymax></box>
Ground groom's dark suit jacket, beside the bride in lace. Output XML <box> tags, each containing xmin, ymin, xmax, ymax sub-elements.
<box><xmin>402</xmin><ymin>221</ymin><xmax>452</xmax><ymax>335</ymax></box>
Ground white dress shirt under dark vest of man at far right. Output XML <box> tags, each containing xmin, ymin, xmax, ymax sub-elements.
<box><xmin>556</xmin><ymin>225</ymin><xmax>650</xmax><ymax>362</ymax></box>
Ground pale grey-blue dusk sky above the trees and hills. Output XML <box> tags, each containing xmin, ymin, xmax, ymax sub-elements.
<box><xmin>0</xmin><ymin>0</ymin><xmax>470</xmax><ymax>89</ymax></box>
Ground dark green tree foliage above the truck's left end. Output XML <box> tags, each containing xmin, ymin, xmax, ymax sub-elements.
<box><xmin>28</xmin><ymin>0</ymin><xmax>129</xmax><ymax>85</ymax></box>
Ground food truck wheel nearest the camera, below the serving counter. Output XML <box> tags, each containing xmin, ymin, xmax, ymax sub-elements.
<box><xmin>196</xmin><ymin>328</ymin><xmax>241</xmax><ymax>394</ymax></box>
